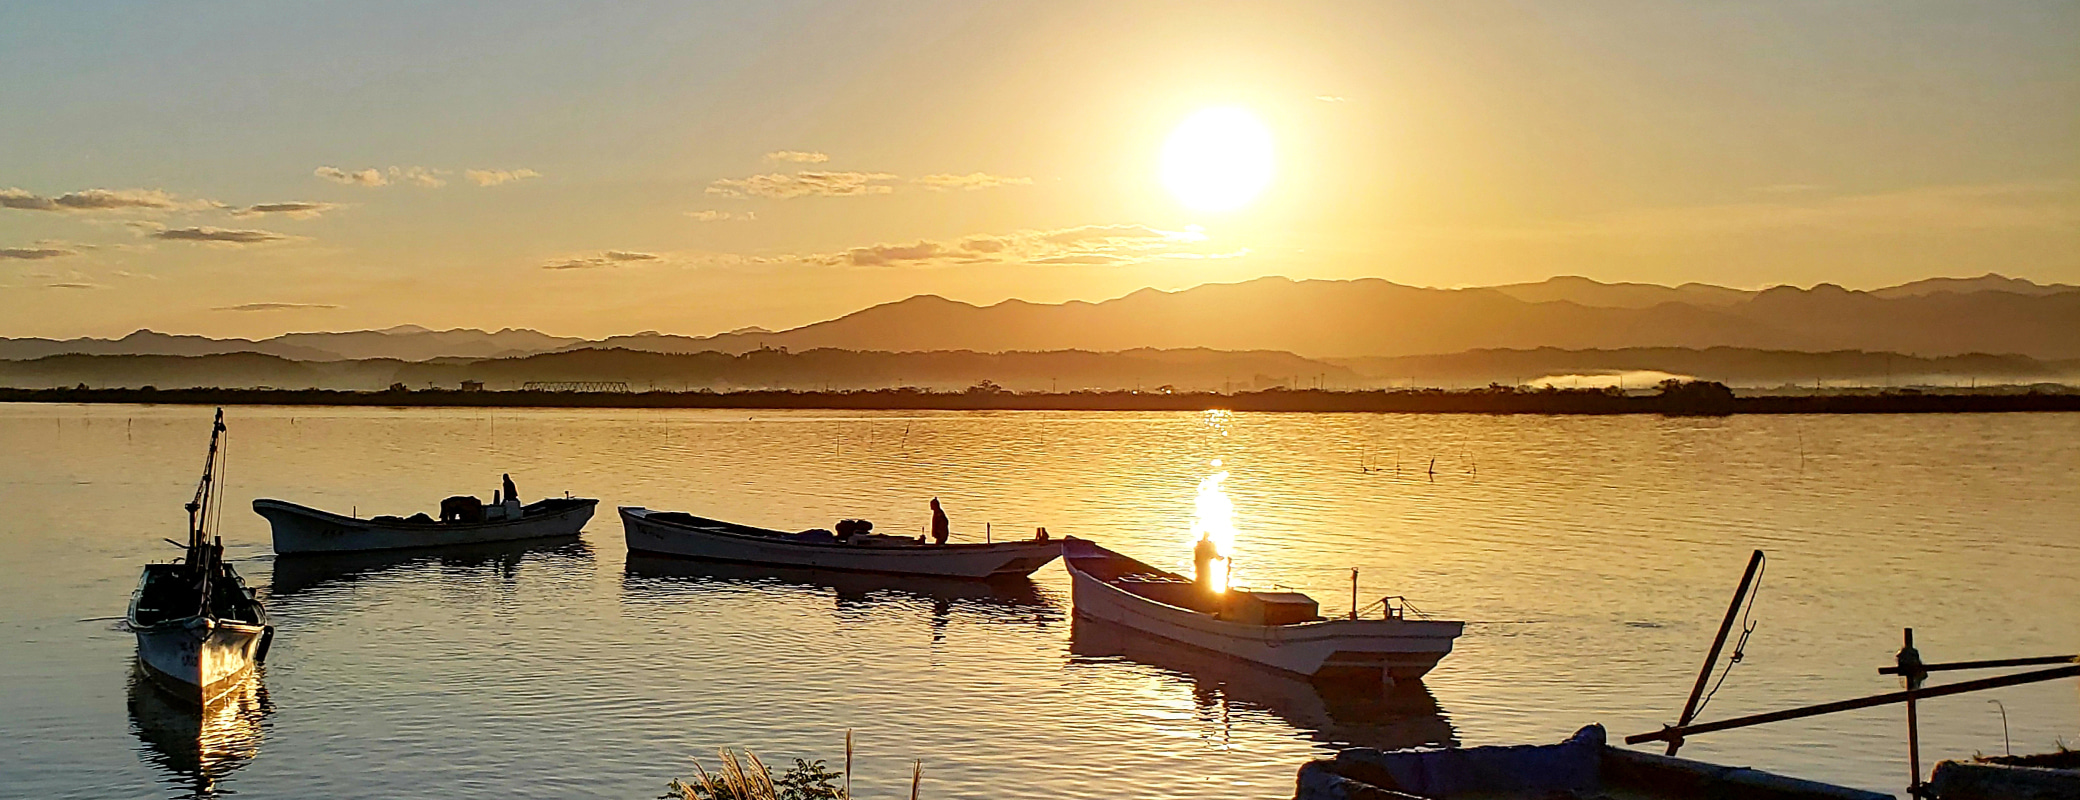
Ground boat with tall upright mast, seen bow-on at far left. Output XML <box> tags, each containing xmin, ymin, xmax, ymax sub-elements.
<box><xmin>127</xmin><ymin>409</ymin><xmax>275</xmax><ymax>706</ymax></box>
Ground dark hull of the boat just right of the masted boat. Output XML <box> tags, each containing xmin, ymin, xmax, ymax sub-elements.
<box><xmin>254</xmin><ymin>499</ymin><xmax>599</xmax><ymax>555</ymax></box>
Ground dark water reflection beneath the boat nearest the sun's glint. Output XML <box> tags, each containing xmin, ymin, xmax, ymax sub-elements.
<box><xmin>1069</xmin><ymin>617</ymin><xmax>1458</xmax><ymax>750</ymax></box>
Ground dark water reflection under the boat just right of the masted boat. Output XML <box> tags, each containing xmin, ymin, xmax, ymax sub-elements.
<box><xmin>268</xmin><ymin>536</ymin><xmax>593</xmax><ymax>598</ymax></box>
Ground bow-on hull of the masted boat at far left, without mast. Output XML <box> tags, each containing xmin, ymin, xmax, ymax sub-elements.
<box><xmin>135</xmin><ymin>617</ymin><xmax>266</xmax><ymax>706</ymax></box>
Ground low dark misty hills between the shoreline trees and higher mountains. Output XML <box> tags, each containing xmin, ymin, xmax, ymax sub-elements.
<box><xmin>0</xmin><ymin>347</ymin><xmax>2080</xmax><ymax>393</ymax></box>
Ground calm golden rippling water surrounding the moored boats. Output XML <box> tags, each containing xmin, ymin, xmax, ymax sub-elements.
<box><xmin>0</xmin><ymin>405</ymin><xmax>2080</xmax><ymax>800</ymax></box>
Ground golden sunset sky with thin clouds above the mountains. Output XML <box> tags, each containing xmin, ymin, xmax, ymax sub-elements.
<box><xmin>0</xmin><ymin>0</ymin><xmax>2080</xmax><ymax>337</ymax></box>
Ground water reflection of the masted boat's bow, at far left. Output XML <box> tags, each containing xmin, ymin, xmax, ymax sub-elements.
<box><xmin>129</xmin><ymin>665</ymin><xmax>275</xmax><ymax>798</ymax></box>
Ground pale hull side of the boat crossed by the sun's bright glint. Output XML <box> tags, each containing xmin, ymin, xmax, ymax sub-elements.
<box><xmin>1065</xmin><ymin>540</ymin><xmax>1464</xmax><ymax>682</ymax></box>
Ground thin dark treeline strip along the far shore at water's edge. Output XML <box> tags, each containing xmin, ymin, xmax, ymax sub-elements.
<box><xmin>0</xmin><ymin>382</ymin><xmax>2080</xmax><ymax>416</ymax></box>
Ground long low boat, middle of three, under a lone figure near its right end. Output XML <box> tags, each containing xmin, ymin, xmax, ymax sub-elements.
<box><xmin>622</xmin><ymin>505</ymin><xmax>1061</xmax><ymax>578</ymax></box>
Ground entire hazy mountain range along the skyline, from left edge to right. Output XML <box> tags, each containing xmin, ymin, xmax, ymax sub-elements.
<box><xmin>0</xmin><ymin>274</ymin><xmax>2080</xmax><ymax>362</ymax></box>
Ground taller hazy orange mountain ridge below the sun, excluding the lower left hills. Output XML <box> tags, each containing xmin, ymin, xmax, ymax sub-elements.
<box><xmin>678</xmin><ymin>278</ymin><xmax>2080</xmax><ymax>359</ymax></box>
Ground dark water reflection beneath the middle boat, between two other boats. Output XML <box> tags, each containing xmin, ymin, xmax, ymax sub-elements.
<box><xmin>622</xmin><ymin>553</ymin><xmax>1061</xmax><ymax>640</ymax></box>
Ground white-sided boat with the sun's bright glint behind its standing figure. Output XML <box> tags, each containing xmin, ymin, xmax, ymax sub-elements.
<box><xmin>1061</xmin><ymin>536</ymin><xmax>1466</xmax><ymax>682</ymax></box>
